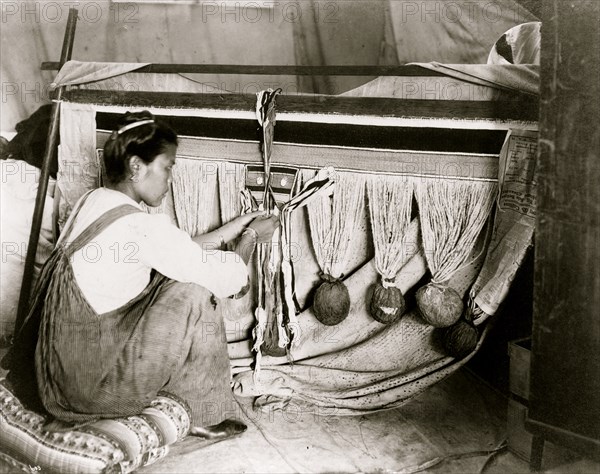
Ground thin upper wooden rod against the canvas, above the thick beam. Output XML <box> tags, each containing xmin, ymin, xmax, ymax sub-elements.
<box><xmin>41</xmin><ymin>61</ymin><xmax>444</xmax><ymax>77</ymax></box>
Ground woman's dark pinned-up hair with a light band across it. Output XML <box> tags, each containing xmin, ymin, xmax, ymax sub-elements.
<box><xmin>103</xmin><ymin>110</ymin><xmax>177</xmax><ymax>183</ymax></box>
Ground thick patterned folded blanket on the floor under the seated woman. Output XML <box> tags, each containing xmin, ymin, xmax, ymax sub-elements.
<box><xmin>0</xmin><ymin>380</ymin><xmax>190</xmax><ymax>474</ymax></box>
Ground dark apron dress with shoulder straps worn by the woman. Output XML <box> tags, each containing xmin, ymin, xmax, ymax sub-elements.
<box><xmin>5</xmin><ymin>194</ymin><xmax>238</xmax><ymax>426</ymax></box>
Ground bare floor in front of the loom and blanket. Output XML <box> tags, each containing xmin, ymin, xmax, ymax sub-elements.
<box><xmin>140</xmin><ymin>370</ymin><xmax>600</xmax><ymax>474</ymax></box>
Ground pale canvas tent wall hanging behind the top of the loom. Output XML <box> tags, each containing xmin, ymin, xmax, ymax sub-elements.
<box><xmin>0</xmin><ymin>0</ymin><xmax>536</xmax><ymax>131</ymax></box>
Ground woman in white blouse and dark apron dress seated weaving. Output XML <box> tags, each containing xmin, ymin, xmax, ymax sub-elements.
<box><xmin>2</xmin><ymin>112</ymin><xmax>278</xmax><ymax>437</ymax></box>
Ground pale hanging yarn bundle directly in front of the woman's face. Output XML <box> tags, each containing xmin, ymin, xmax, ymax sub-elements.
<box><xmin>173</xmin><ymin>158</ymin><xmax>218</xmax><ymax>237</ymax></box>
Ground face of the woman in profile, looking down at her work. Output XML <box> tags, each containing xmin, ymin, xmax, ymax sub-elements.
<box><xmin>133</xmin><ymin>145</ymin><xmax>177</xmax><ymax>207</ymax></box>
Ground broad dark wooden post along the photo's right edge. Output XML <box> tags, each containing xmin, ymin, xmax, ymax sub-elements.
<box><xmin>527</xmin><ymin>0</ymin><xmax>600</xmax><ymax>457</ymax></box>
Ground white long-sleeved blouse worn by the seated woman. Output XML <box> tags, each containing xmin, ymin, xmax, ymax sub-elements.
<box><xmin>61</xmin><ymin>188</ymin><xmax>248</xmax><ymax>314</ymax></box>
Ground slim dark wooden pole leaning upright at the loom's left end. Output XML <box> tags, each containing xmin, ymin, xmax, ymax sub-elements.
<box><xmin>14</xmin><ymin>7</ymin><xmax>77</xmax><ymax>334</ymax></box>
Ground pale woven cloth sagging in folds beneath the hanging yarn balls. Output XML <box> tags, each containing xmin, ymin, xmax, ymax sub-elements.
<box><xmin>229</xmin><ymin>223</ymin><xmax>483</xmax><ymax>415</ymax></box>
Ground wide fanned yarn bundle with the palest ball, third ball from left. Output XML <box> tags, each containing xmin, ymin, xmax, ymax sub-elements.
<box><xmin>415</xmin><ymin>179</ymin><xmax>496</xmax><ymax>327</ymax></box>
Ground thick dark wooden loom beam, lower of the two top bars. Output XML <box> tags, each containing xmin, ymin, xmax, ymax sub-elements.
<box><xmin>66</xmin><ymin>89</ymin><xmax>538</xmax><ymax>123</ymax></box>
